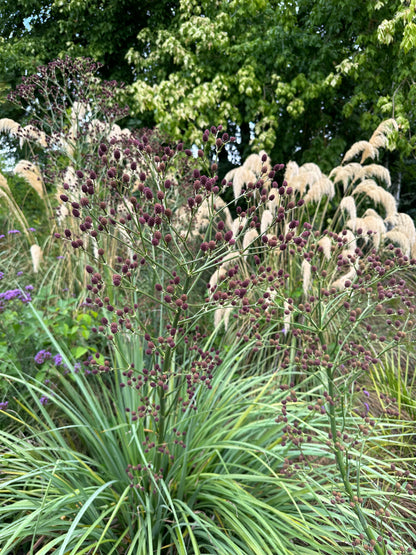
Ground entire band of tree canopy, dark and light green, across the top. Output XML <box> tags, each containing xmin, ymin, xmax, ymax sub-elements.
<box><xmin>0</xmin><ymin>0</ymin><xmax>416</xmax><ymax>213</ymax></box>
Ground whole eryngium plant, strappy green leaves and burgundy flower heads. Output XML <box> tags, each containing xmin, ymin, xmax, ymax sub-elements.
<box><xmin>0</xmin><ymin>124</ymin><xmax>415</xmax><ymax>554</ymax></box>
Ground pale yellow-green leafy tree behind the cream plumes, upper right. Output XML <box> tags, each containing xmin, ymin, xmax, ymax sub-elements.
<box><xmin>128</xmin><ymin>0</ymin><xmax>416</xmax><ymax>215</ymax></box>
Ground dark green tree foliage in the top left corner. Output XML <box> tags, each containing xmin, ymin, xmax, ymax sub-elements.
<box><xmin>0</xmin><ymin>0</ymin><xmax>179</xmax><ymax>85</ymax></box>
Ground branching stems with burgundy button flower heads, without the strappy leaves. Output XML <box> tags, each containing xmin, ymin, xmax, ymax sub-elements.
<box><xmin>53</xmin><ymin>128</ymin><xmax>415</xmax><ymax>552</ymax></box>
